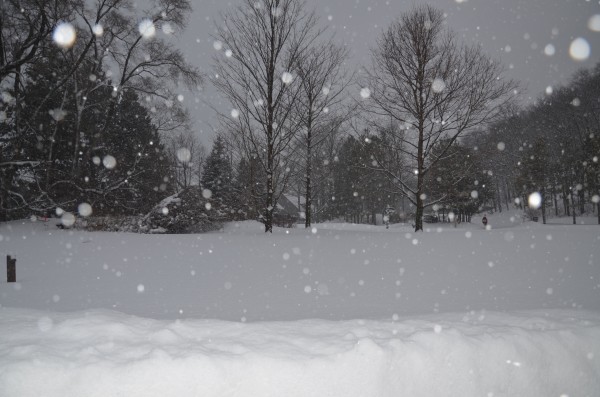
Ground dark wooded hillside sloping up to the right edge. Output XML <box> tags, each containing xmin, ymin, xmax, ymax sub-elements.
<box><xmin>472</xmin><ymin>64</ymin><xmax>600</xmax><ymax>223</ymax></box>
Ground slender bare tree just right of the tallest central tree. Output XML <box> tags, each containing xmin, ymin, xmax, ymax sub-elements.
<box><xmin>295</xmin><ymin>42</ymin><xmax>351</xmax><ymax>228</ymax></box>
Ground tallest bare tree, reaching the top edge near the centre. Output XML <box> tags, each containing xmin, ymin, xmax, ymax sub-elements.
<box><xmin>213</xmin><ymin>0</ymin><xmax>319</xmax><ymax>232</ymax></box>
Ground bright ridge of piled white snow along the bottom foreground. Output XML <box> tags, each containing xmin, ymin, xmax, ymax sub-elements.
<box><xmin>0</xmin><ymin>309</ymin><xmax>600</xmax><ymax>397</ymax></box>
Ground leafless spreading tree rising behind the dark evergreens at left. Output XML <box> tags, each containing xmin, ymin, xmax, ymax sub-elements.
<box><xmin>88</xmin><ymin>0</ymin><xmax>202</xmax><ymax>163</ymax></box>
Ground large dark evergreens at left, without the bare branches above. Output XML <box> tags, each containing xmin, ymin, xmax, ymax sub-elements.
<box><xmin>2</xmin><ymin>45</ymin><xmax>169</xmax><ymax>217</ymax></box>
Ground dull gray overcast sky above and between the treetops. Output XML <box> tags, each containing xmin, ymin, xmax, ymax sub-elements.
<box><xmin>170</xmin><ymin>0</ymin><xmax>600</xmax><ymax>145</ymax></box>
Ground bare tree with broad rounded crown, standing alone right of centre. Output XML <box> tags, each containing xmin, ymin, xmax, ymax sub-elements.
<box><xmin>361</xmin><ymin>6</ymin><xmax>516</xmax><ymax>231</ymax></box>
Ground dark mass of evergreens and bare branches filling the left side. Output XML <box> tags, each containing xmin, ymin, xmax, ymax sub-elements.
<box><xmin>0</xmin><ymin>0</ymin><xmax>201</xmax><ymax>220</ymax></box>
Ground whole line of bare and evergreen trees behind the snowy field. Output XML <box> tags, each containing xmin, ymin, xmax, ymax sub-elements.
<box><xmin>0</xmin><ymin>0</ymin><xmax>599</xmax><ymax>232</ymax></box>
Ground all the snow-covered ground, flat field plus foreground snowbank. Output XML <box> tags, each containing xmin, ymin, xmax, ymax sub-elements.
<box><xmin>0</xmin><ymin>213</ymin><xmax>600</xmax><ymax>397</ymax></box>
